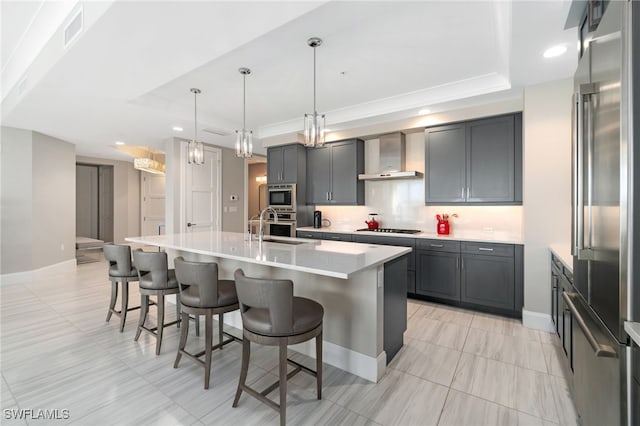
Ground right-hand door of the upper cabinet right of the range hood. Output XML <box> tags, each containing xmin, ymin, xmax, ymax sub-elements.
<box><xmin>466</xmin><ymin>115</ymin><xmax>515</xmax><ymax>203</ymax></box>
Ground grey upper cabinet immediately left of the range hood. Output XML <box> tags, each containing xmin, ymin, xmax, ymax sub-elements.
<box><xmin>307</xmin><ymin>139</ymin><xmax>364</xmax><ymax>205</ymax></box>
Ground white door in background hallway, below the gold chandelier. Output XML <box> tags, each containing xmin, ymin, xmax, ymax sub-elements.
<box><xmin>140</xmin><ymin>172</ymin><xmax>166</xmax><ymax>236</ymax></box>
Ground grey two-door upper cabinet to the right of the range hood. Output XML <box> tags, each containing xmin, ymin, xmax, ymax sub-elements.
<box><xmin>425</xmin><ymin>113</ymin><xmax>522</xmax><ymax>204</ymax></box>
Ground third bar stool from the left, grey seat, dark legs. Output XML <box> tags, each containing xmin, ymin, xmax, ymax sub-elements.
<box><xmin>173</xmin><ymin>257</ymin><xmax>238</xmax><ymax>389</ymax></box>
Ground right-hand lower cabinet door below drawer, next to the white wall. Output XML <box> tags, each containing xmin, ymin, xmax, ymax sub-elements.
<box><xmin>460</xmin><ymin>254</ymin><xmax>515</xmax><ymax>311</ymax></box>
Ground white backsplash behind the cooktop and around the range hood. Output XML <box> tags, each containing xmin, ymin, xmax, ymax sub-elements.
<box><xmin>317</xmin><ymin>133</ymin><xmax>524</xmax><ymax>235</ymax></box>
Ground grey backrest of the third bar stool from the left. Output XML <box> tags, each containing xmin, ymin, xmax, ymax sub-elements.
<box><xmin>173</xmin><ymin>256</ymin><xmax>218</xmax><ymax>307</ymax></box>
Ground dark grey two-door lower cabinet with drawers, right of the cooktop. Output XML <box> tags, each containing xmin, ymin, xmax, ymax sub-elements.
<box><xmin>416</xmin><ymin>239</ymin><xmax>523</xmax><ymax>316</ymax></box>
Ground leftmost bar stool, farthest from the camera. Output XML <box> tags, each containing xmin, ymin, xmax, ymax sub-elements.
<box><xmin>102</xmin><ymin>244</ymin><xmax>140</xmax><ymax>333</ymax></box>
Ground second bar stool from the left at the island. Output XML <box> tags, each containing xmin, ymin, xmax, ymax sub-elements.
<box><xmin>133</xmin><ymin>249</ymin><xmax>180</xmax><ymax>355</ymax></box>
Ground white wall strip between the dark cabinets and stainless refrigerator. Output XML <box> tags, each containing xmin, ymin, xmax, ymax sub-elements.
<box><xmin>523</xmin><ymin>79</ymin><xmax>573</xmax><ymax>320</ymax></box>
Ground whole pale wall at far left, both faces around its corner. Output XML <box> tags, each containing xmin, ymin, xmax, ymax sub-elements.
<box><xmin>1</xmin><ymin>127</ymin><xmax>75</xmax><ymax>274</ymax></box>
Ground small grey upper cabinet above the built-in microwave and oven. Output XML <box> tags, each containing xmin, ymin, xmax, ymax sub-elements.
<box><xmin>267</xmin><ymin>143</ymin><xmax>307</xmax><ymax>184</ymax></box>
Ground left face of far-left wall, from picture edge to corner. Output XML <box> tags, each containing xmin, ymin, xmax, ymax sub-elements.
<box><xmin>0</xmin><ymin>127</ymin><xmax>33</xmax><ymax>274</ymax></box>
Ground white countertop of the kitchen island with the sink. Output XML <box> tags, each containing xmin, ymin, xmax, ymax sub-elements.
<box><xmin>125</xmin><ymin>232</ymin><xmax>411</xmax><ymax>279</ymax></box>
